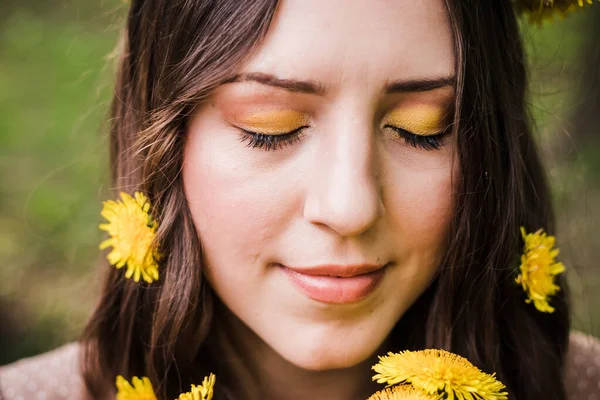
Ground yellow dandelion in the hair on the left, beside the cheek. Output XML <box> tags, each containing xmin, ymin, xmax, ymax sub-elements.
<box><xmin>100</xmin><ymin>192</ymin><xmax>160</xmax><ymax>283</ymax></box>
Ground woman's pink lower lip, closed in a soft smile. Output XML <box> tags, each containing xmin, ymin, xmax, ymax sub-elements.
<box><xmin>281</xmin><ymin>266</ymin><xmax>385</xmax><ymax>304</ymax></box>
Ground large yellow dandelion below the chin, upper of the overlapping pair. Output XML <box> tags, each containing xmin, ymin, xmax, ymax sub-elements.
<box><xmin>373</xmin><ymin>349</ymin><xmax>508</xmax><ymax>400</ymax></box>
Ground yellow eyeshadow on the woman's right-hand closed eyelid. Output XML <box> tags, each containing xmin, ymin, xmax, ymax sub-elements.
<box><xmin>381</xmin><ymin>106</ymin><xmax>446</xmax><ymax>136</ymax></box>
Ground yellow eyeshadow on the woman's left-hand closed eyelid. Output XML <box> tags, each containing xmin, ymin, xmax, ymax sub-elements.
<box><xmin>237</xmin><ymin>110</ymin><xmax>310</xmax><ymax>135</ymax></box>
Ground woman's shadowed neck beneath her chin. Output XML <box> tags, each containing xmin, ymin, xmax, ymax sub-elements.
<box><xmin>215</xmin><ymin>305</ymin><xmax>383</xmax><ymax>400</ymax></box>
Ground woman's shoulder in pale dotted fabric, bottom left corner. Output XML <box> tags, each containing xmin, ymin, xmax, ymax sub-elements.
<box><xmin>0</xmin><ymin>343</ymin><xmax>89</xmax><ymax>400</ymax></box>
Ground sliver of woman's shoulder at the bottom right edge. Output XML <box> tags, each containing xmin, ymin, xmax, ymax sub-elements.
<box><xmin>565</xmin><ymin>332</ymin><xmax>600</xmax><ymax>400</ymax></box>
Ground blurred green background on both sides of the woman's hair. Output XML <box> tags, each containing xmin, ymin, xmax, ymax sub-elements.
<box><xmin>0</xmin><ymin>0</ymin><xmax>600</xmax><ymax>365</ymax></box>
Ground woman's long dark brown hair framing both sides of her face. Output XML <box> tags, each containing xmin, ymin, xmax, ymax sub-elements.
<box><xmin>82</xmin><ymin>0</ymin><xmax>570</xmax><ymax>400</ymax></box>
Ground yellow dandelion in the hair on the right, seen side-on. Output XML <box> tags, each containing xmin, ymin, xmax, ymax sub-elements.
<box><xmin>516</xmin><ymin>228</ymin><xmax>565</xmax><ymax>313</ymax></box>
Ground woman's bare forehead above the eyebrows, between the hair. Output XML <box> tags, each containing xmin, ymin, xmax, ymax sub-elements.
<box><xmin>243</xmin><ymin>0</ymin><xmax>454</xmax><ymax>86</ymax></box>
